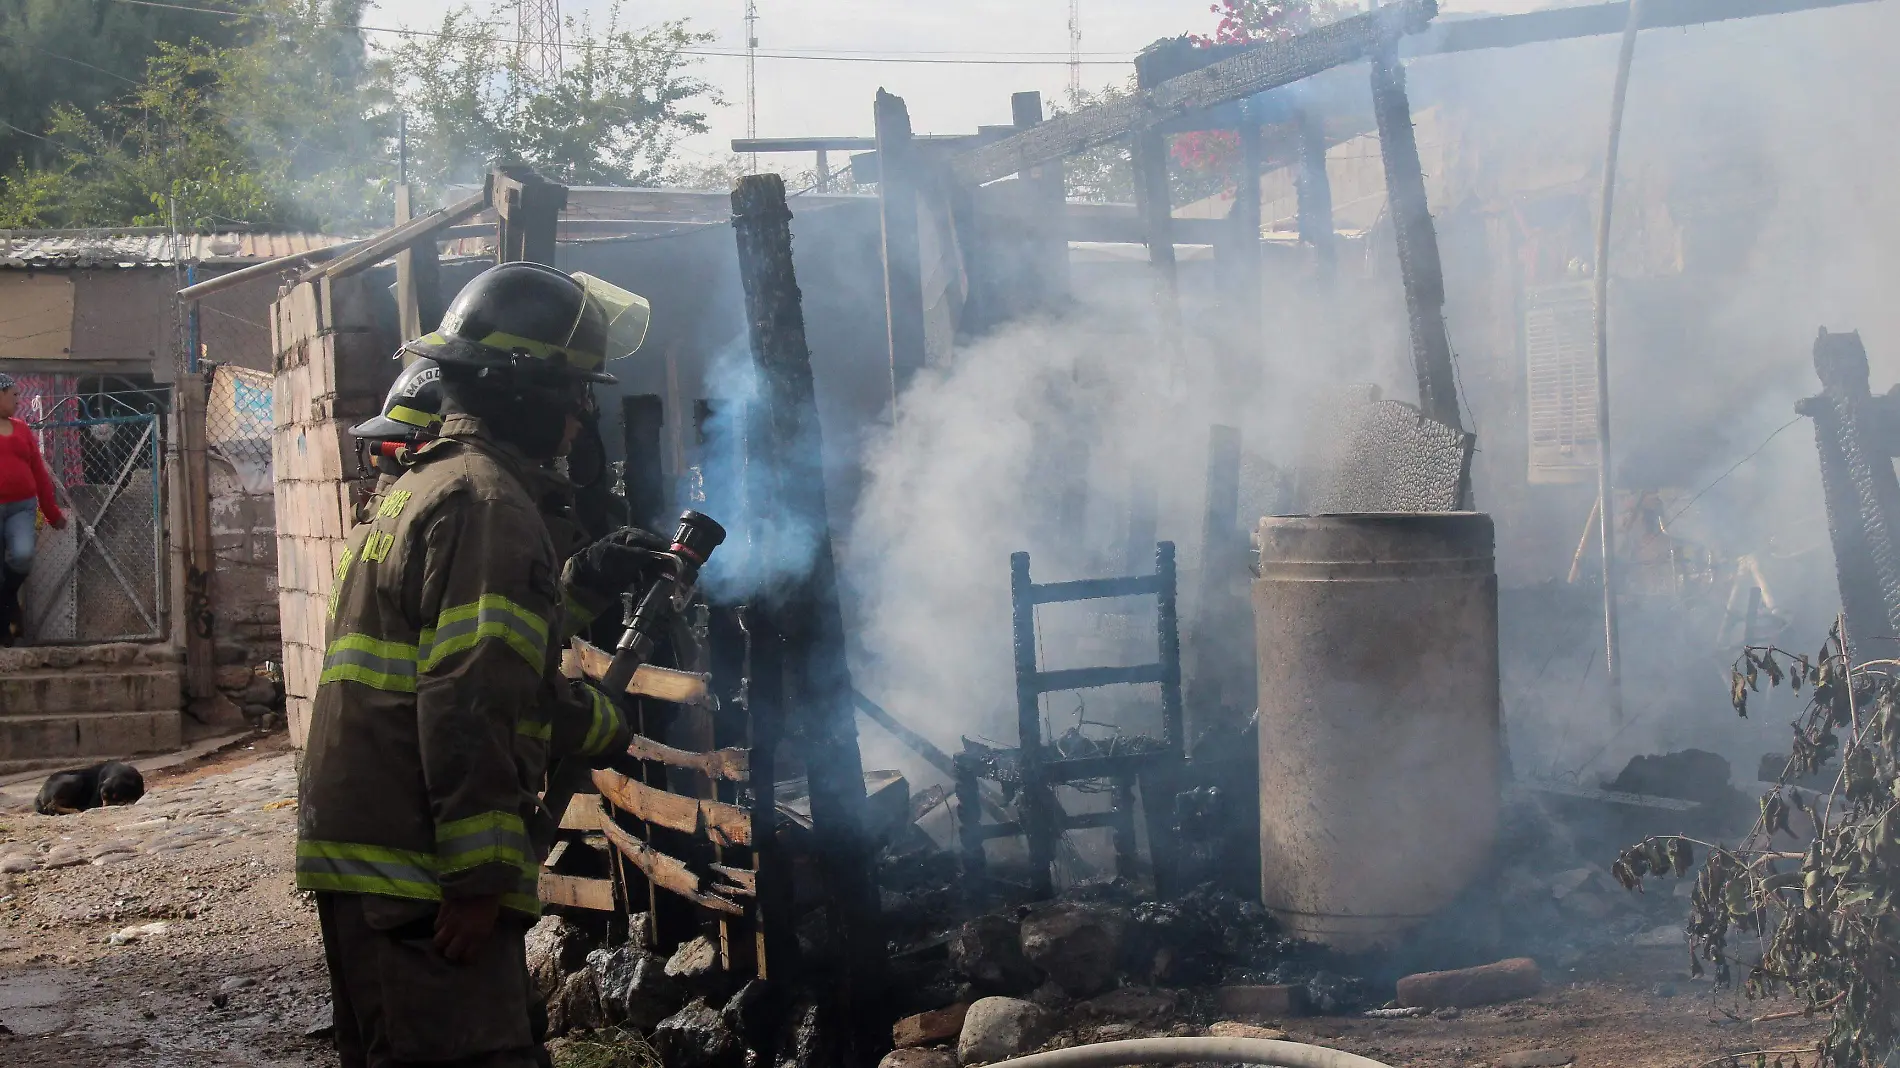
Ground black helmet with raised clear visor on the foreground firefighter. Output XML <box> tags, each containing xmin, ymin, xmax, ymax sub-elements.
<box><xmin>403</xmin><ymin>262</ymin><xmax>650</xmax><ymax>382</ymax></box>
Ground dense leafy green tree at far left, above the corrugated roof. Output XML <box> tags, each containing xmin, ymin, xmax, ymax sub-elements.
<box><xmin>0</xmin><ymin>0</ymin><xmax>391</xmax><ymax>230</ymax></box>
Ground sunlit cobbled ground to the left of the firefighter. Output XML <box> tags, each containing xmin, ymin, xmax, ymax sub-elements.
<box><xmin>0</xmin><ymin>735</ymin><xmax>334</xmax><ymax>1068</ymax></box>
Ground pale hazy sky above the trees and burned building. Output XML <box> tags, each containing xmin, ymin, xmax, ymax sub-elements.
<box><xmin>363</xmin><ymin>0</ymin><xmax>1535</xmax><ymax>167</ymax></box>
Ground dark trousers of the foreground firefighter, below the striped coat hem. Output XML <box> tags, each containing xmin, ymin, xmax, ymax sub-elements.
<box><xmin>317</xmin><ymin>893</ymin><xmax>549</xmax><ymax>1068</ymax></box>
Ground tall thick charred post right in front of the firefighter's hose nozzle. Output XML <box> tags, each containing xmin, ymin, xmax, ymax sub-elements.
<box><xmin>732</xmin><ymin>175</ymin><xmax>884</xmax><ymax>1058</ymax></box>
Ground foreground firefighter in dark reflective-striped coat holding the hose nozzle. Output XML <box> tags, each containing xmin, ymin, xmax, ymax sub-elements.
<box><xmin>296</xmin><ymin>262</ymin><xmax>659</xmax><ymax>1068</ymax></box>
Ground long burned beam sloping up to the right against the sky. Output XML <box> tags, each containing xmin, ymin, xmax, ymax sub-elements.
<box><xmin>950</xmin><ymin>0</ymin><xmax>1438</xmax><ymax>184</ymax></box>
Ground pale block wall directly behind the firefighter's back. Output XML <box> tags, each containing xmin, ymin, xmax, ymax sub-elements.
<box><xmin>270</xmin><ymin>272</ymin><xmax>397</xmax><ymax>747</ymax></box>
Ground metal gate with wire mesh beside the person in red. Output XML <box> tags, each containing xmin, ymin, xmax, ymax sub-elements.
<box><xmin>21</xmin><ymin>405</ymin><xmax>165</xmax><ymax>644</ymax></box>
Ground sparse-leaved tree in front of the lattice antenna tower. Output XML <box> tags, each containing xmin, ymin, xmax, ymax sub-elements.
<box><xmin>390</xmin><ymin>2</ymin><xmax>722</xmax><ymax>188</ymax></box>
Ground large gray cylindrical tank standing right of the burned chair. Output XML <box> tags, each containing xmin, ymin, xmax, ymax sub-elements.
<box><xmin>1254</xmin><ymin>511</ymin><xmax>1501</xmax><ymax>952</ymax></box>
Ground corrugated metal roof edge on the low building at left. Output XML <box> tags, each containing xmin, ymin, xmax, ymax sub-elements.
<box><xmin>0</xmin><ymin>228</ymin><xmax>352</xmax><ymax>268</ymax></box>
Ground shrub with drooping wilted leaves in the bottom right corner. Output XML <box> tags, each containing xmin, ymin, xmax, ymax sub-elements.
<box><xmin>1613</xmin><ymin>629</ymin><xmax>1900</xmax><ymax>1068</ymax></box>
